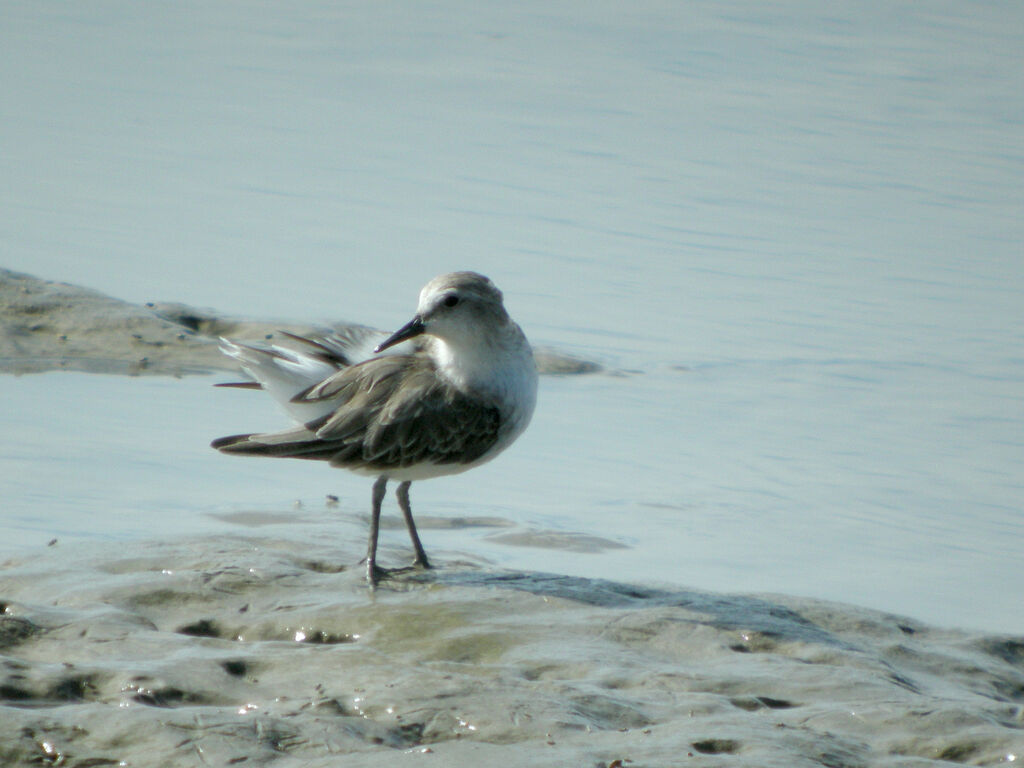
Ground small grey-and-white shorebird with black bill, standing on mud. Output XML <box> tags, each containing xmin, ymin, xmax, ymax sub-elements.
<box><xmin>211</xmin><ymin>272</ymin><xmax>537</xmax><ymax>586</ymax></box>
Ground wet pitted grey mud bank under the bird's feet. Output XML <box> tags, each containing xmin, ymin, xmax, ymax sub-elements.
<box><xmin>0</xmin><ymin>537</ymin><xmax>1024</xmax><ymax>767</ymax></box>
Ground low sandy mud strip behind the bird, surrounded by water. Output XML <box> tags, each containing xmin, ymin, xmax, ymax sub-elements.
<box><xmin>0</xmin><ymin>268</ymin><xmax>600</xmax><ymax>376</ymax></box>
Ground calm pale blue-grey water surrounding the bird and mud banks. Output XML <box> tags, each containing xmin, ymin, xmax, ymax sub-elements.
<box><xmin>0</xmin><ymin>2</ymin><xmax>1024</xmax><ymax>632</ymax></box>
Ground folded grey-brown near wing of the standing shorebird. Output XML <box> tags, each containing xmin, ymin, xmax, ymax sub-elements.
<box><xmin>214</xmin><ymin>355</ymin><xmax>501</xmax><ymax>471</ymax></box>
